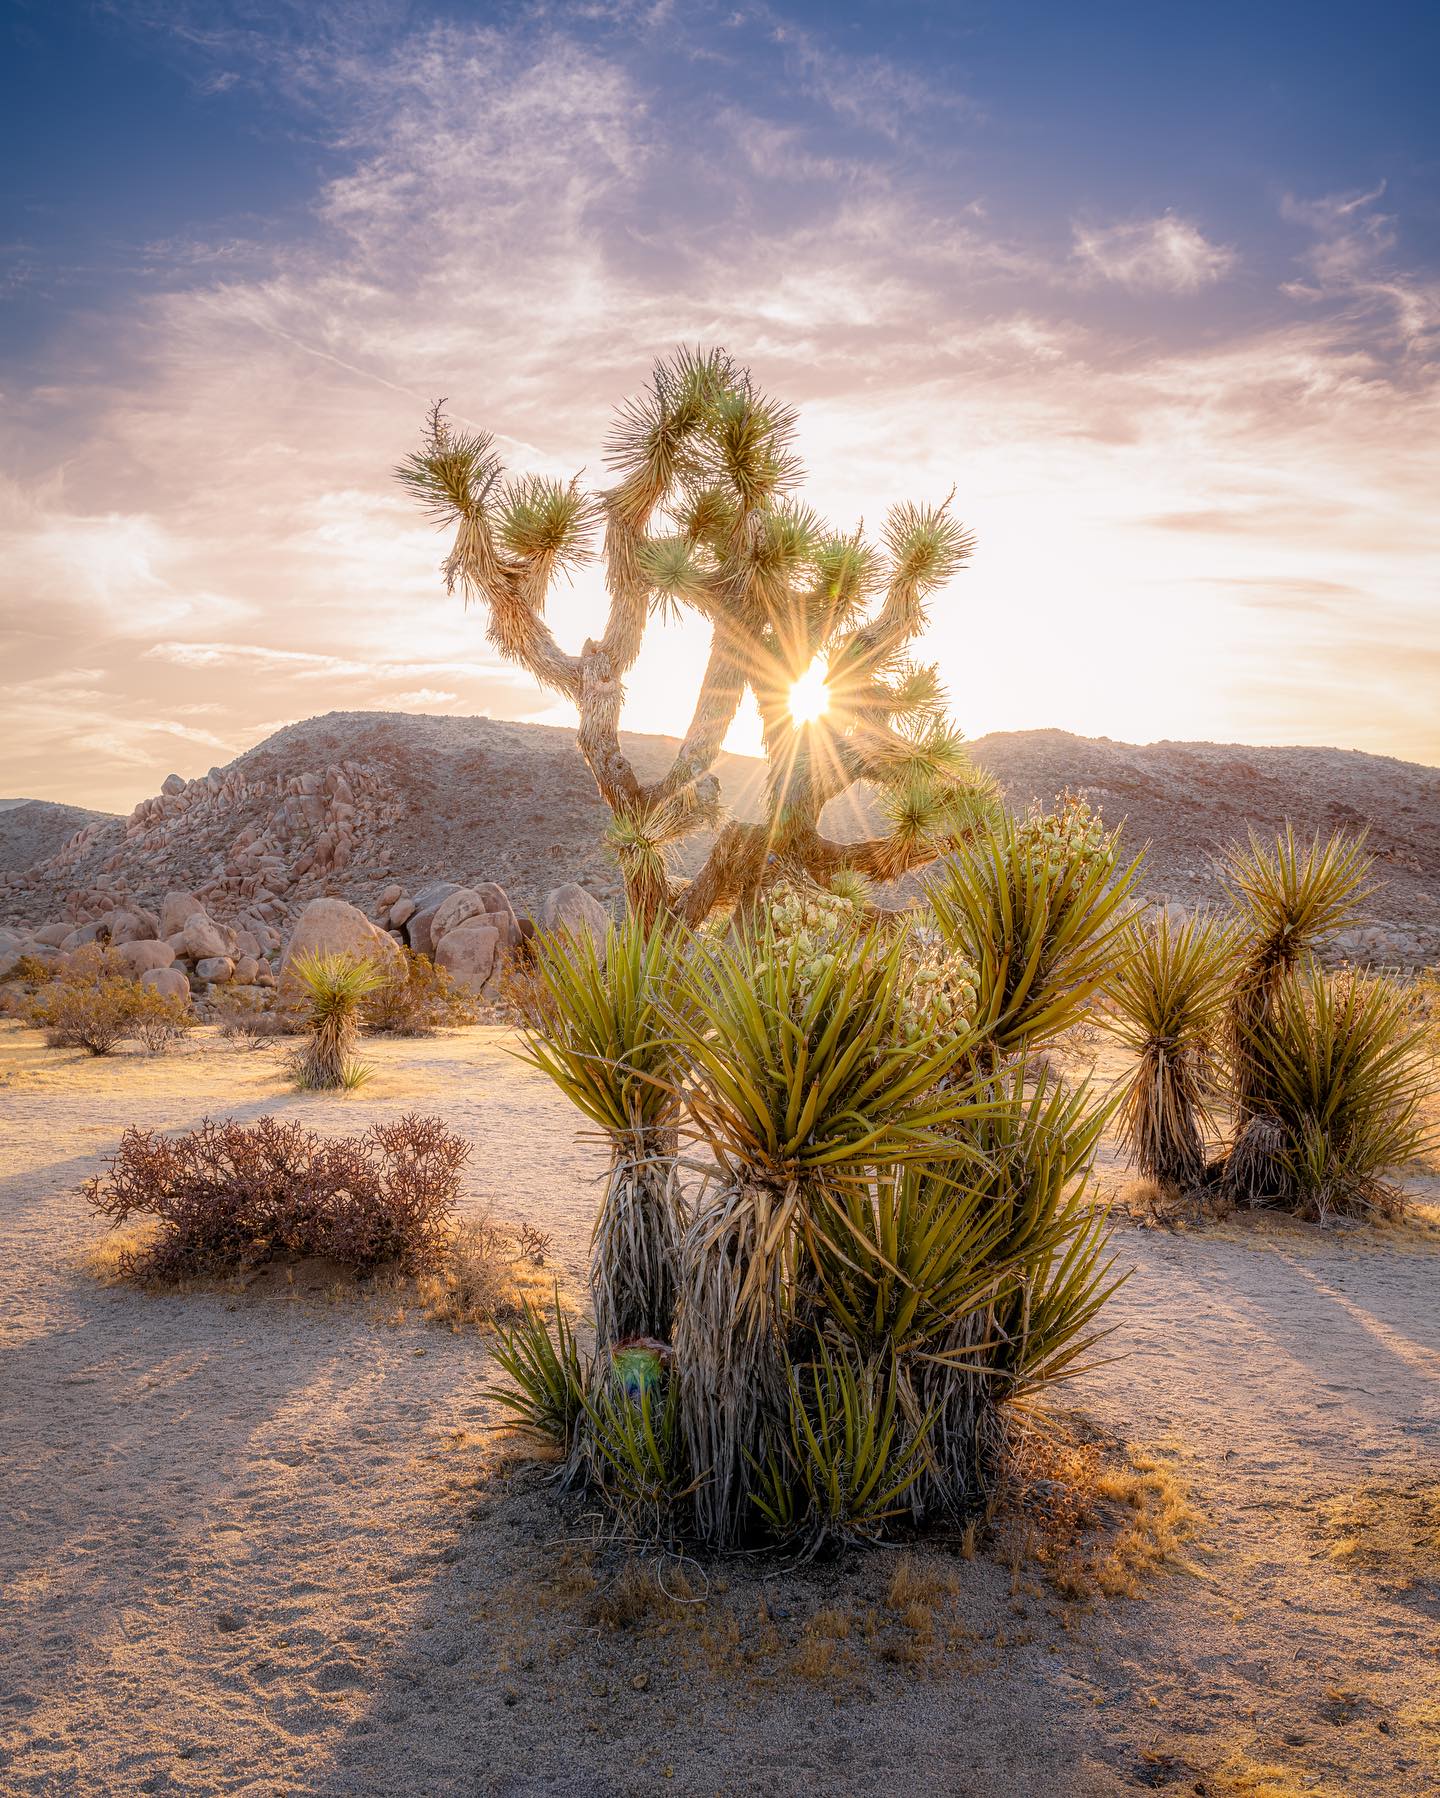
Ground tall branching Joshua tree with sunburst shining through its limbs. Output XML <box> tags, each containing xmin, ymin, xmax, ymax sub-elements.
<box><xmin>397</xmin><ymin>351</ymin><xmax>992</xmax><ymax>924</ymax></box>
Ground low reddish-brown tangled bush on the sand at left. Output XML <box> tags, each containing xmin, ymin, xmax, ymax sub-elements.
<box><xmin>84</xmin><ymin>1117</ymin><xmax>469</xmax><ymax>1280</ymax></box>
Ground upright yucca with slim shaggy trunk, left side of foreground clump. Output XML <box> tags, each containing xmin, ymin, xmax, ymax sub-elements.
<box><xmin>523</xmin><ymin>917</ymin><xmax>685</xmax><ymax>1349</ymax></box>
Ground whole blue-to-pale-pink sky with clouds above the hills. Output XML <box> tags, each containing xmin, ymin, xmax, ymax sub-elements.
<box><xmin>0</xmin><ymin>0</ymin><xmax>1440</xmax><ymax>809</ymax></box>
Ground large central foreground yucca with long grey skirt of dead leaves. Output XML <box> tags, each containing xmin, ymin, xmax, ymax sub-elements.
<box><xmin>674</xmin><ymin>919</ymin><xmax>983</xmax><ymax>1544</ymax></box>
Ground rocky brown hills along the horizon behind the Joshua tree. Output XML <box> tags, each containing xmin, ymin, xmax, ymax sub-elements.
<box><xmin>0</xmin><ymin>712</ymin><xmax>1440</xmax><ymax>962</ymax></box>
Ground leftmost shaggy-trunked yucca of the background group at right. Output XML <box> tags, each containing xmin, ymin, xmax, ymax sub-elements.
<box><xmin>1104</xmin><ymin>912</ymin><xmax>1237</xmax><ymax>1192</ymax></box>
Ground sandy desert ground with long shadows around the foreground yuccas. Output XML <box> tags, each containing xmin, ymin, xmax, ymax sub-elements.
<box><xmin>0</xmin><ymin>1025</ymin><xmax>1440</xmax><ymax>1798</ymax></box>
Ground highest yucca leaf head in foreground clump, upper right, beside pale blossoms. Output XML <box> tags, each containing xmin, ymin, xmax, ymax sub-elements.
<box><xmin>926</xmin><ymin>800</ymin><xmax>1142</xmax><ymax>1066</ymax></box>
